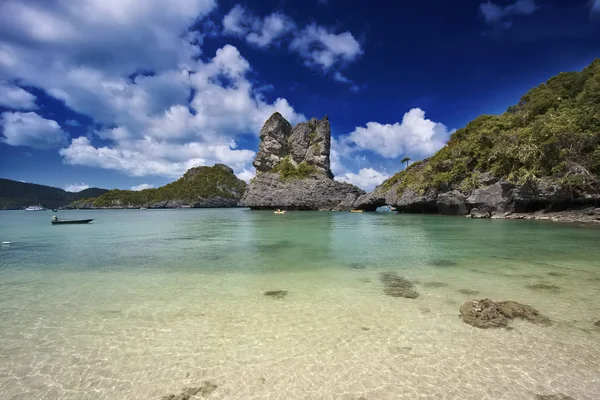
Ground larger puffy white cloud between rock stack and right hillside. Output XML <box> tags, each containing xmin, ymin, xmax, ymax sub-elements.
<box><xmin>340</xmin><ymin>108</ymin><xmax>451</xmax><ymax>158</ymax></box>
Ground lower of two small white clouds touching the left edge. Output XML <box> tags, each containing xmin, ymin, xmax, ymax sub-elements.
<box><xmin>0</xmin><ymin>111</ymin><xmax>67</xmax><ymax>150</ymax></box>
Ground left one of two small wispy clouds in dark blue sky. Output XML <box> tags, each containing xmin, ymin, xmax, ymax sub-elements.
<box><xmin>223</xmin><ymin>4</ymin><xmax>295</xmax><ymax>47</ymax></box>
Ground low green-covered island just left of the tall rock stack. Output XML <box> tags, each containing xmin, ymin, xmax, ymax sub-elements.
<box><xmin>74</xmin><ymin>164</ymin><xmax>246</xmax><ymax>208</ymax></box>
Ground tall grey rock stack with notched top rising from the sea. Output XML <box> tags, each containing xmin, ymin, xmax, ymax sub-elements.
<box><xmin>240</xmin><ymin>113</ymin><xmax>365</xmax><ymax>210</ymax></box>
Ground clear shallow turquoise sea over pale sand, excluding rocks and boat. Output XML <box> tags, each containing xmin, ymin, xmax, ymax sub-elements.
<box><xmin>0</xmin><ymin>209</ymin><xmax>600</xmax><ymax>400</ymax></box>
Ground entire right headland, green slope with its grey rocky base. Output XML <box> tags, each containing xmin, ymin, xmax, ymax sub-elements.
<box><xmin>355</xmin><ymin>60</ymin><xmax>600</xmax><ymax>218</ymax></box>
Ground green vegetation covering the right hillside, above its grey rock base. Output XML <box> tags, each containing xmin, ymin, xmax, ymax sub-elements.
<box><xmin>384</xmin><ymin>59</ymin><xmax>600</xmax><ymax>193</ymax></box>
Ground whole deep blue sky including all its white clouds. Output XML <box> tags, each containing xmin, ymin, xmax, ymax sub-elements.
<box><xmin>0</xmin><ymin>0</ymin><xmax>600</xmax><ymax>191</ymax></box>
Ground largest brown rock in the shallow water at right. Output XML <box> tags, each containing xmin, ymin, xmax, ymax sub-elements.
<box><xmin>459</xmin><ymin>299</ymin><xmax>550</xmax><ymax>328</ymax></box>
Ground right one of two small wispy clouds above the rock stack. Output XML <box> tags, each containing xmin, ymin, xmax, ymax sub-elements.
<box><xmin>290</xmin><ymin>24</ymin><xmax>363</xmax><ymax>71</ymax></box>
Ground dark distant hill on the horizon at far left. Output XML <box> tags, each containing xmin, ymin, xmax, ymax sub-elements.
<box><xmin>0</xmin><ymin>179</ymin><xmax>107</xmax><ymax>210</ymax></box>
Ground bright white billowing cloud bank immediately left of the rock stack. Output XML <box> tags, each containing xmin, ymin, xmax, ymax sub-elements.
<box><xmin>60</xmin><ymin>45</ymin><xmax>305</xmax><ymax>177</ymax></box>
